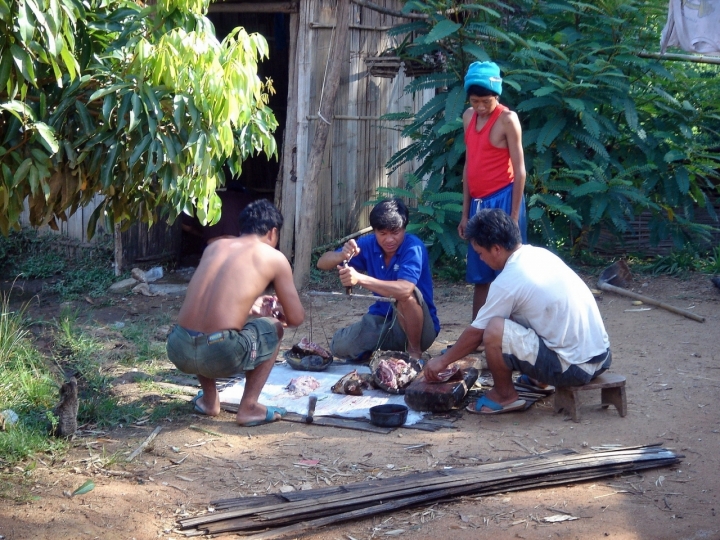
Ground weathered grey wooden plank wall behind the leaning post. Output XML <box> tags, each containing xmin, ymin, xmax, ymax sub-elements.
<box><xmin>296</xmin><ymin>0</ymin><xmax>434</xmax><ymax>245</ymax></box>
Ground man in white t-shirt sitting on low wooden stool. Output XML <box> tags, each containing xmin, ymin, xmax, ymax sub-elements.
<box><xmin>424</xmin><ymin>209</ymin><xmax>612</xmax><ymax>414</ymax></box>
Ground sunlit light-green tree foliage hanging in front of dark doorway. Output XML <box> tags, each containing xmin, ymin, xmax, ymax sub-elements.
<box><xmin>0</xmin><ymin>0</ymin><xmax>277</xmax><ymax>236</ymax></box>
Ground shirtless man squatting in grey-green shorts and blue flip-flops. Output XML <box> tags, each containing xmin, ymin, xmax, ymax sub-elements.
<box><xmin>167</xmin><ymin>199</ymin><xmax>305</xmax><ymax>427</ymax></box>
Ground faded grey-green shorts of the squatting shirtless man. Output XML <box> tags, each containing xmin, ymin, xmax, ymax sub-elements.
<box><xmin>167</xmin><ymin>317</ymin><xmax>280</xmax><ymax>379</ymax></box>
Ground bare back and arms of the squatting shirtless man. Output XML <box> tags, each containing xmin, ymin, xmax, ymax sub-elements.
<box><xmin>178</xmin><ymin>234</ymin><xmax>303</xmax><ymax>333</ymax></box>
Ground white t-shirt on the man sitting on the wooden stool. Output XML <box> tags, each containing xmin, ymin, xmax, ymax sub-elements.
<box><xmin>472</xmin><ymin>245</ymin><xmax>610</xmax><ymax>364</ymax></box>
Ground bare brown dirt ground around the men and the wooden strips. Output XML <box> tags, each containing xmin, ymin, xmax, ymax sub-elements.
<box><xmin>0</xmin><ymin>275</ymin><xmax>720</xmax><ymax>540</ymax></box>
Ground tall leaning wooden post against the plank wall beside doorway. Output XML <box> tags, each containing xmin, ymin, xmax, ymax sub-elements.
<box><xmin>294</xmin><ymin>0</ymin><xmax>350</xmax><ymax>289</ymax></box>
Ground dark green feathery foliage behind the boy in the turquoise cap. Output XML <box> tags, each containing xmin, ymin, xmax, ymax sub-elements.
<box><xmin>387</xmin><ymin>0</ymin><xmax>720</xmax><ymax>256</ymax></box>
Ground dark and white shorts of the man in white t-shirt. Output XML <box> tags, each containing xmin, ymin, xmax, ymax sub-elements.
<box><xmin>502</xmin><ymin>320</ymin><xmax>612</xmax><ymax>387</ymax></box>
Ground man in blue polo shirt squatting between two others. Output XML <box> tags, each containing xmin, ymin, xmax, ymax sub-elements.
<box><xmin>317</xmin><ymin>199</ymin><xmax>440</xmax><ymax>361</ymax></box>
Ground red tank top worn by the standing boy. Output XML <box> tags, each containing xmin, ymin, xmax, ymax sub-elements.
<box><xmin>465</xmin><ymin>103</ymin><xmax>515</xmax><ymax>199</ymax></box>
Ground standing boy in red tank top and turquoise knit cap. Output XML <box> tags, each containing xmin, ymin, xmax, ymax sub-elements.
<box><xmin>458</xmin><ymin>62</ymin><xmax>527</xmax><ymax>319</ymax></box>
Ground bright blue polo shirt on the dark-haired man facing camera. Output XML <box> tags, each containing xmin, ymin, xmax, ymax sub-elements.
<box><xmin>338</xmin><ymin>234</ymin><xmax>440</xmax><ymax>332</ymax></box>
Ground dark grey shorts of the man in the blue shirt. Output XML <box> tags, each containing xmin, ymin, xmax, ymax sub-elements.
<box><xmin>330</xmin><ymin>287</ymin><xmax>437</xmax><ymax>360</ymax></box>
